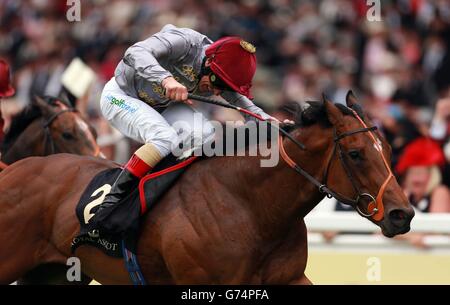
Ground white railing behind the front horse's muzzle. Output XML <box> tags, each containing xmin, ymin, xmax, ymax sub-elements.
<box><xmin>305</xmin><ymin>199</ymin><xmax>450</xmax><ymax>254</ymax></box>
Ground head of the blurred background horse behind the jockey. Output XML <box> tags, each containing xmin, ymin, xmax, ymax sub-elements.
<box><xmin>34</xmin><ymin>97</ymin><xmax>99</xmax><ymax>156</ymax></box>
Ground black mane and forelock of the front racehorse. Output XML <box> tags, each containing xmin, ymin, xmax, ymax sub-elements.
<box><xmin>282</xmin><ymin>101</ymin><xmax>364</xmax><ymax>131</ymax></box>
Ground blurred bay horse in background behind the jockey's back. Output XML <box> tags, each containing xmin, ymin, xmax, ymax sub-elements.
<box><xmin>0</xmin><ymin>96</ymin><xmax>100</xmax><ymax>167</ymax></box>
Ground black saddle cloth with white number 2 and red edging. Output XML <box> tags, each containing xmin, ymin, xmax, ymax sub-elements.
<box><xmin>72</xmin><ymin>155</ymin><xmax>197</xmax><ymax>257</ymax></box>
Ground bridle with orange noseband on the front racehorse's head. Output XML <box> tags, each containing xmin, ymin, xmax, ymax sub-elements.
<box><xmin>278</xmin><ymin>108</ymin><xmax>394</xmax><ymax>221</ymax></box>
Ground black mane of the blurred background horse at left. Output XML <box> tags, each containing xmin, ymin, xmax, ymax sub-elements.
<box><xmin>0</xmin><ymin>96</ymin><xmax>69</xmax><ymax>154</ymax></box>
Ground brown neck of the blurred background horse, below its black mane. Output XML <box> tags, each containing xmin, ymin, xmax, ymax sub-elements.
<box><xmin>2</xmin><ymin>119</ymin><xmax>45</xmax><ymax>164</ymax></box>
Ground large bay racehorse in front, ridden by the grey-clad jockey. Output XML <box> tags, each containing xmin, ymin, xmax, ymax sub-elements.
<box><xmin>0</xmin><ymin>93</ymin><xmax>414</xmax><ymax>284</ymax></box>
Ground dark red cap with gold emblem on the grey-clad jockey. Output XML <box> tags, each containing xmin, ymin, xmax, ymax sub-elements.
<box><xmin>205</xmin><ymin>37</ymin><xmax>256</xmax><ymax>99</ymax></box>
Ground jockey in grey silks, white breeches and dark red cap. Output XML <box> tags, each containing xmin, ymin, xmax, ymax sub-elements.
<box><xmin>90</xmin><ymin>24</ymin><xmax>271</xmax><ymax>231</ymax></box>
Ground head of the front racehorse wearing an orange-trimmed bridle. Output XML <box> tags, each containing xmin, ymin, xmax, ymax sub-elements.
<box><xmin>324</xmin><ymin>91</ymin><xmax>414</xmax><ymax>237</ymax></box>
